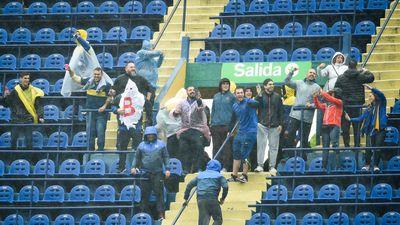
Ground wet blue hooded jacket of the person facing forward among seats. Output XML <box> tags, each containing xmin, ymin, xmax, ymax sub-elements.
<box><xmin>132</xmin><ymin>127</ymin><xmax>169</xmax><ymax>173</ymax></box>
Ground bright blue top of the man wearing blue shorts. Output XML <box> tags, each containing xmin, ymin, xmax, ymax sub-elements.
<box><xmin>233</xmin><ymin>98</ymin><xmax>258</xmax><ymax>133</ymax></box>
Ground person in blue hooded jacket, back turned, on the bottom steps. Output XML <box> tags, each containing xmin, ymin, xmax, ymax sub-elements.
<box><xmin>183</xmin><ymin>159</ymin><xmax>228</xmax><ymax>225</ymax></box>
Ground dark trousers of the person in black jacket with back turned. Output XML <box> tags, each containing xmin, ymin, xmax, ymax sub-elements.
<box><xmin>342</xmin><ymin>107</ymin><xmax>360</xmax><ymax>147</ymax></box>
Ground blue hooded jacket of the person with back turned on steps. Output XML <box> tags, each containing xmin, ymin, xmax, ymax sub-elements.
<box><xmin>184</xmin><ymin>159</ymin><xmax>228</xmax><ymax>200</ymax></box>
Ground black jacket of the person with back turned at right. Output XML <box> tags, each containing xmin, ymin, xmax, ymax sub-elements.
<box><xmin>335</xmin><ymin>69</ymin><xmax>375</xmax><ymax>106</ymax></box>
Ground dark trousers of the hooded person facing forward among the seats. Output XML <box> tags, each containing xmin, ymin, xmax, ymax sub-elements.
<box><xmin>140</xmin><ymin>172</ymin><xmax>164</xmax><ymax>215</ymax></box>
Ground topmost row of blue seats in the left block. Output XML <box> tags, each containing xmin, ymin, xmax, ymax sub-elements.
<box><xmin>3</xmin><ymin>0</ymin><xmax>167</xmax><ymax>15</ymax></box>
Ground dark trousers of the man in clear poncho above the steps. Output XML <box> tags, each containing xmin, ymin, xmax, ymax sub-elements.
<box><xmin>178</xmin><ymin>129</ymin><xmax>204</xmax><ymax>173</ymax></box>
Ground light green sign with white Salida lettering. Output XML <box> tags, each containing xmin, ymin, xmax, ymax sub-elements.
<box><xmin>221</xmin><ymin>61</ymin><xmax>311</xmax><ymax>84</ymax></box>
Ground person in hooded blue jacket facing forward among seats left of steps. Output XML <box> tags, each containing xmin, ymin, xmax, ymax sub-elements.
<box><xmin>131</xmin><ymin>127</ymin><xmax>170</xmax><ymax>219</ymax></box>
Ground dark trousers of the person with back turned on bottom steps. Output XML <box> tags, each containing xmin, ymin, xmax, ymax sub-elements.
<box><xmin>197</xmin><ymin>199</ymin><xmax>222</xmax><ymax>225</ymax></box>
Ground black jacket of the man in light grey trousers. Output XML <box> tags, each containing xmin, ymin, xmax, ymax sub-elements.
<box><xmin>256</xmin><ymin>91</ymin><xmax>283</xmax><ymax>128</ymax></box>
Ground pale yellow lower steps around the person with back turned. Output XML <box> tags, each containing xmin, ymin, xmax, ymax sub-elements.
<box><xmin>162</xmin><ymin>173</ymin><xmax>270</xmax><ymax>225</ymax></box>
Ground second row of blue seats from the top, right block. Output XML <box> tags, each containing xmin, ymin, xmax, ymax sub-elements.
<box><xmin>211</xmin><ymin>20</ymin><xmax>375</xmax><ymax>38</ymax></box>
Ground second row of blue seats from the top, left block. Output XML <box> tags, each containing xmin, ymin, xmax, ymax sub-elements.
<box><xmin>0</xmin><ymin>25</ymin><xmax>152</xmax><ymax>45</ymax></box>
